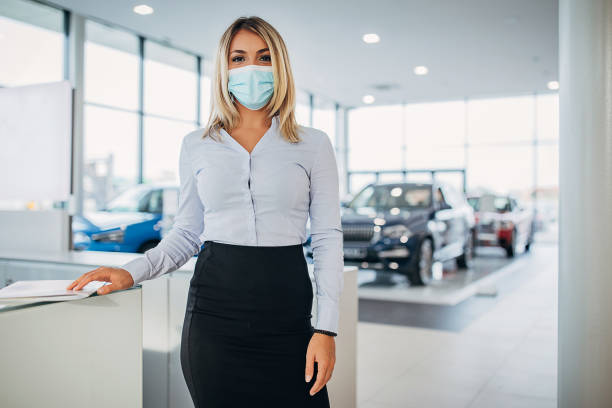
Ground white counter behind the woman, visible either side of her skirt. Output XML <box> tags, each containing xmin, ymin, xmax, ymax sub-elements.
<box><xmin>0</xmin><ymin>250</ymin><xmax>358</xmax><ymax>408</ymax></box>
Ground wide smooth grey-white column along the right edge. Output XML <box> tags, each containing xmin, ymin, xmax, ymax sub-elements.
<box><xmin>558</xmin><ymin>0</ymin><xmax>612</xmax><ymax>408</ymax></box>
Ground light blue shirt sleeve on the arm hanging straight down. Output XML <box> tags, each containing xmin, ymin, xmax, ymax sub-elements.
<box><xmin>310</xmin><ymin>133</ymin><xmax>344</xmax><ymax>333</ymax></box>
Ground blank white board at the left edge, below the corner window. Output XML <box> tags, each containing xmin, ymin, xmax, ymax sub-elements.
<box><xmin>0</xmin><ymin>81</ymin><xmax>72</xmax><ymax>200</ymax></box>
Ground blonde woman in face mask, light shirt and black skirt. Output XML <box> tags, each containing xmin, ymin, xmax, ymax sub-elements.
<box><xmin>68</xmin><ymin>17</ymin><xmax>344</xmax><ymax>408</ymax></box>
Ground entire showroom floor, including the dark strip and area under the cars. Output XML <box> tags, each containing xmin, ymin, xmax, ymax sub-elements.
<box><xmin>357</xmin><ymin>242</ymin><xmax>557</xmax><ymax>408</ymax></box>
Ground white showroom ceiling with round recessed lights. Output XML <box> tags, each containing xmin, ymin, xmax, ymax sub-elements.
<box><xmin>47</xmin><ymin>0</ymin><xmax>558</xmax><ymax>106</ymax></box>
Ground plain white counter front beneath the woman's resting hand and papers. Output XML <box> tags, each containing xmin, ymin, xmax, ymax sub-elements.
<box><xmin>0</xmin><ymin>286</ymin><xmax>143</xmax><ymax>408</ymax></box>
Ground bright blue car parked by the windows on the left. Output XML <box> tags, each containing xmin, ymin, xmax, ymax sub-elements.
<box><xmin>72</xmin><ymin>184</ymin><xmax>178</xmax><ymax>253</ymax></box>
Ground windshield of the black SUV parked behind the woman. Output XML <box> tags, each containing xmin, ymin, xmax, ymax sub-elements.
<box><xmin>348</xmin><ymin>185</ymin><xmax>431</xmax><ymax>211</ymax></box>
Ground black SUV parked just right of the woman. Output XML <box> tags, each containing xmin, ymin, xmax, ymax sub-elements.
<box><xmin>342</xmin><ymin>182</ymin><xmax>474</xmax><ymax>285</ymax></box>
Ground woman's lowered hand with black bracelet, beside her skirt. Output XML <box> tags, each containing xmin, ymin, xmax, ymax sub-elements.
<box><xmin>306</xmin><ymin>333</ymin><xmax>336</xmax><ymax>395</ymax></box>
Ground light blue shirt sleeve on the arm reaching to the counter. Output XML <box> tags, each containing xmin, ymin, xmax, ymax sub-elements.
<box><xmin>121</xmin><ymin>134</ymin><xmax>204</xmax><ymax>285</ymax></box>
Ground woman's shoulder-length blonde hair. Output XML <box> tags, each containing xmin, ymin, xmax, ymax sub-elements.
<box><xmin>202</xmin><ymin>17</ymin><xmax>301</xmax><ymax>143</ymax></box>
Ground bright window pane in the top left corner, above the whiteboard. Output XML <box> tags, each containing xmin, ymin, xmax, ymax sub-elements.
<box><xmin>0</xmin><ymin>0</ymin><xmax>64</xmax><ymax>87</ymax></box>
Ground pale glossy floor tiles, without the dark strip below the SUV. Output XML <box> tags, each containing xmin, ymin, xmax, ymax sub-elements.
<box><xmin>357</xmin><ymin>244</ymin><xmax>557</xmax><ymax>408</ymax></box>
